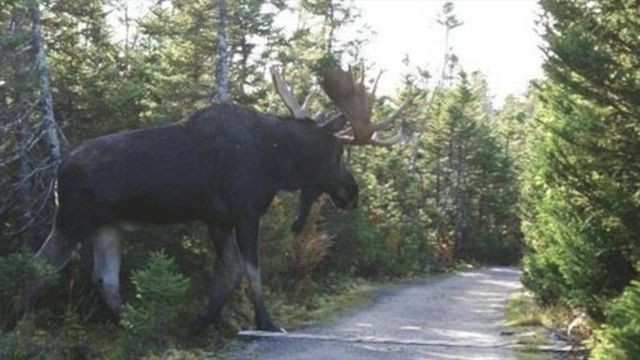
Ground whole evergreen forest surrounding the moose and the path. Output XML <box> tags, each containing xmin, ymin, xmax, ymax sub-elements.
<box><xmin>0</xmin><ymin>0</ymin><xmax>640</xmax><ymax>359</ymax></box>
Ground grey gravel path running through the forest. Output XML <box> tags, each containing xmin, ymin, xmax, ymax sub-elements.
<box><xmin>220</xmin><ymin>267</ymin><xmax>520</xmax><ymax>360</ymax></box>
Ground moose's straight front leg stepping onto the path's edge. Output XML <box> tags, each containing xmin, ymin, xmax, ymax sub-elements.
<box><xmin>236</xmin><ymin>216</ymin><xmax>284</xmax><ymax>332</ymax></box>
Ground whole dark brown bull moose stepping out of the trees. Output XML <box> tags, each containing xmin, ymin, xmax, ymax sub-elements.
<box><xmin>18</xmin><ymin>68</ymin><xmax>408</xmax><ymax>333</ymax></box>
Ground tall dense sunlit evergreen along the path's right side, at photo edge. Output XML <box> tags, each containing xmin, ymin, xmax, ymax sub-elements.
<box><xmin>521</xmin><ymin>0</ymin><xmax>640</xmax><ymax>324</ymax></box>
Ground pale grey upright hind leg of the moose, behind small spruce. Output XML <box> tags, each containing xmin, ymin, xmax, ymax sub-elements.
<box><xmin>92</xmin><ymin>226</ymin><xmax>122</xmax><ymax>317</ymax></box>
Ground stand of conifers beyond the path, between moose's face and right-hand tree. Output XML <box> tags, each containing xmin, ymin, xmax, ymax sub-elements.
<box><xmin>318</xmin><ymin>68</ymin><xmax>520</xmax><ymax>277</ymax></box>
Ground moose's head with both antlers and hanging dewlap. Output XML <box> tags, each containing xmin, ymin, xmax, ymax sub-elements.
<box><xmin>270</xmin><ymin>67</ymin><xmax>411</xmax><ymax>232</ymax></box>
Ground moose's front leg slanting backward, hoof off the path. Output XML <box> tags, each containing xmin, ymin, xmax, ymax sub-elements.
<box><xmin>191</xmin><ymin>225</ymin><xmax>243</xmax><ymax>334</ymax></box>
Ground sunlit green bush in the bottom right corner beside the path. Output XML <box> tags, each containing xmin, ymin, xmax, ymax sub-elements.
<box><xmin>591</xmin><ymin>280</ymin><xmax>640</xmax><ymax>360</ymax></box>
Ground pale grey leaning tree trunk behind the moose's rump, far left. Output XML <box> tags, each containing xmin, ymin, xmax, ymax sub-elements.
<box><xmin>28</xmin><ymin>0</ymin><xmax>61</xmax><ymax>170</ymax></box>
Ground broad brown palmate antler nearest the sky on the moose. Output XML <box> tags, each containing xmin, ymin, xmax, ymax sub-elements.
<box><xmin>320</xmin><ymin>68</ymin><xmax>411</xmax><ymax>146</ymax></box>
